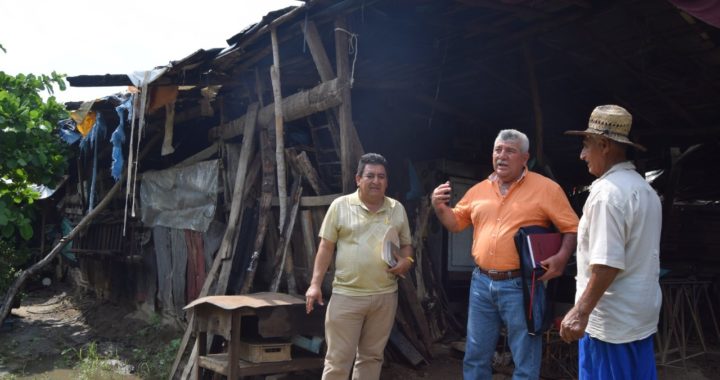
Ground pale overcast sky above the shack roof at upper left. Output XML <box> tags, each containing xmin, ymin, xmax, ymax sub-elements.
<box><xmin>0</xmin><ymin>0</ymin><xmax>302</xmax><ymax>102</ymax></box>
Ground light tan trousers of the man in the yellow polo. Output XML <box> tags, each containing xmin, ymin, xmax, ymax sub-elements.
<box><xmin>322</xmin><ymin>293</ymin><xmax>397</xmax><ymax>380</ymax></box>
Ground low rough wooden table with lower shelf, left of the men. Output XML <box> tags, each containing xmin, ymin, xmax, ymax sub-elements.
<box><xmin>185</xmin><ymin>292</ymin><xmax>323</xmax><ymax>379</ymax></box>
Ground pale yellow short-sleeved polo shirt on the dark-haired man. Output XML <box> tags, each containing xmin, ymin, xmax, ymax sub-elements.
<box><xmin>320</xmin><ymin>191</ymin><xmax>412</xmax><ymax>296</ymax></box>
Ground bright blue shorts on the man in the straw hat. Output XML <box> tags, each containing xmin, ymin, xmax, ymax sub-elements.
<box><xmin>578</xmin><ymin>333</ymin><xmax>657</xmax><ymax>380</ymax></box>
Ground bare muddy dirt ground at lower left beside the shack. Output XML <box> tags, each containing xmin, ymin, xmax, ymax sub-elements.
<box><xmin>0</xmin><ymin>284</ymin><xmax>182</xmax><ymax>380</ymax></box>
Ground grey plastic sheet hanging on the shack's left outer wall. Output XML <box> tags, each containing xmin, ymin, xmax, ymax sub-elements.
<box><xmin>140</xmin><ymin>160</ymin><xmax>219</xmax><ymax>232</ymax></box>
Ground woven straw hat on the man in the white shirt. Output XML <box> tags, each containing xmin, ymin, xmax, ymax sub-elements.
<box><xmin>565</xmin><ymin>104</ymin><xmax>647</xmax><ymax>152</ymax></box>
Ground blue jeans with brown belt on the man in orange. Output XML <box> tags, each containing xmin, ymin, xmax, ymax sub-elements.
<box><xmin>463</xmin><ymin>269</ymin><xmax>542</xmax><ymax>380</ymax></box>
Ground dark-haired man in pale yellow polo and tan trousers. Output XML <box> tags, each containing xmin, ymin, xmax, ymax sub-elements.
<box><xmin>305</xmin><ymin>153</ymin><xmax>413</xmax><ymax>380</ymax></box>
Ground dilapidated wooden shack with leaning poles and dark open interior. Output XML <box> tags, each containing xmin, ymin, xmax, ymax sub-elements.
<box><xmin>33</xmin><ymin>0</ymin><xmax>720</xmax><ymax>378</ymax></box>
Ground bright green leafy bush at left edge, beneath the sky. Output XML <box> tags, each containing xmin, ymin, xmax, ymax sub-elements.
<box><xmin>0</xmin><ymin>71</ymin><xmax>69</xmax><ymax>240</ymax></box>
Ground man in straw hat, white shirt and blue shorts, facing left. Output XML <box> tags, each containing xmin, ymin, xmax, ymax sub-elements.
<box><xmin>560</xmin><ymin>105</ymin><xmax>662</xmax><ymax>379</ymax></box>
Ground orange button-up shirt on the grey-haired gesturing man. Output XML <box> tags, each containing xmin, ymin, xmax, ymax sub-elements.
<box><xmin>452</xmin><ymin>169</ymin><xmax>578</xmax><ymax>270</ymax></box>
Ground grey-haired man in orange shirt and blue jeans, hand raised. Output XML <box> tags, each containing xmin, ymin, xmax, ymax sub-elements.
<box><xmin>432</xmin><ymin>129</ymin><xmax>578</xmax><ymax>380</ymax></box>
